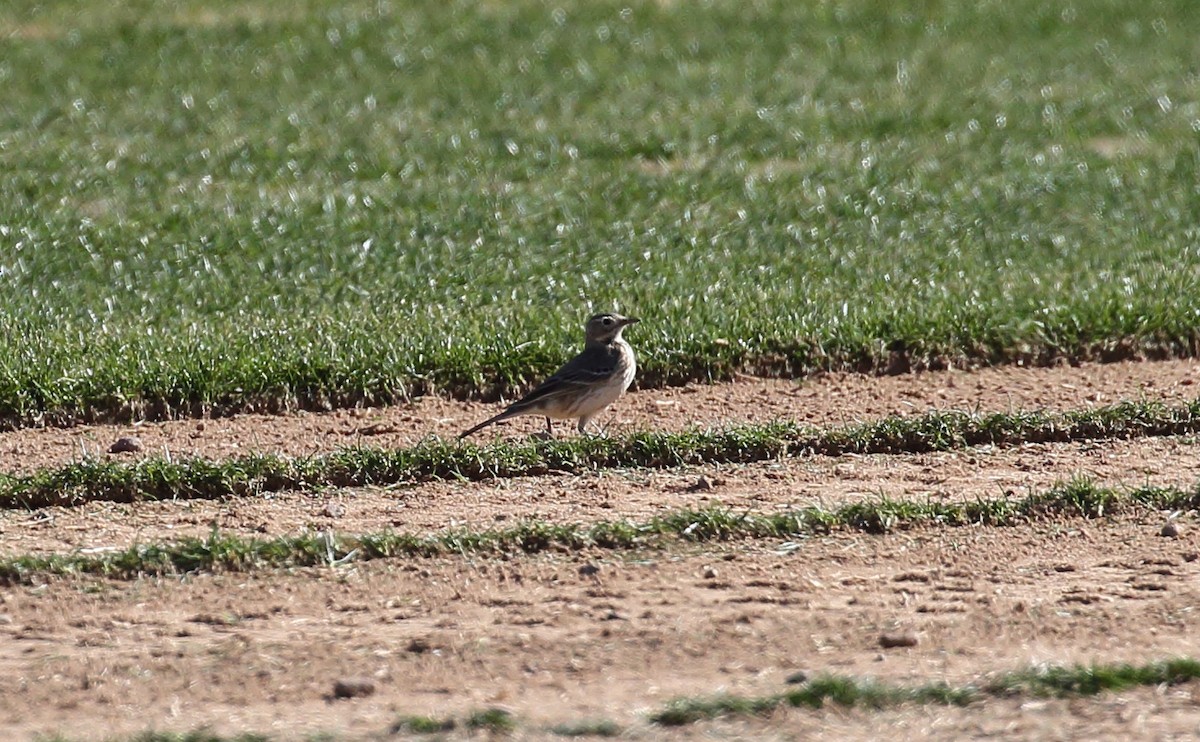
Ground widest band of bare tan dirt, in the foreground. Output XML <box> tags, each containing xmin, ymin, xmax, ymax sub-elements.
<box><xmin>0</xmin><ymin>519</ymin><xmax>1200</xmax><ymax>740</ymax></box>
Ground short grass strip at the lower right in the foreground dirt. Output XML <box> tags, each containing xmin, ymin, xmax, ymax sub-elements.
<box><xmin>650</xmin><ymin>658</ymin><xmax>1200</xmax><ymax>726</ymax></box>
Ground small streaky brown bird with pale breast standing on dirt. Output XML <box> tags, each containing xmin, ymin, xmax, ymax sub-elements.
<box><xmin>458</xmin><ymin>313</ymin><xmax>637</xmax><ymax>439</ymax></box>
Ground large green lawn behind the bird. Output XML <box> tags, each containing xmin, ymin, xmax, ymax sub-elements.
<box><xmin>0</xmin><ymin>0</ymin><xmax>1200</xmax><ymax>424</ymax></box>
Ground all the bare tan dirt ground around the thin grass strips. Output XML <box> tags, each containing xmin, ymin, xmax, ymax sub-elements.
<box><xmin>0</xmin><ymin>363</ymin><xmax>1200</xmax><ymax>740</ymax></box>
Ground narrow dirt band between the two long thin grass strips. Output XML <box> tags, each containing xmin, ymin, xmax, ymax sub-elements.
<box><xmin>0</xmin><ymin>437</ymin><xmax>1200</xmax><ymax>555</ymax></box>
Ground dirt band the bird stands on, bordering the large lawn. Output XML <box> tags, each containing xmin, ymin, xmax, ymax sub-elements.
<box><xmin>0</xmin><ymin>360</ymin><xmax>1200</xmax><ymax>473</ymax></box>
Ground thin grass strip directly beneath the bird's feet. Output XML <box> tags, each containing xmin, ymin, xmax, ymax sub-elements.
<box><xmin>0</xmin><ymin>400</ymin><xmax>1200</xmax><ymax>508</ymax></box>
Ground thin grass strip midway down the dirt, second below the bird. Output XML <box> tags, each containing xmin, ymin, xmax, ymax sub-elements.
<box><xmin>0</xmin><ymin>478</ymin><xmax>1200</xmax><ymax>585</ymax></box>
